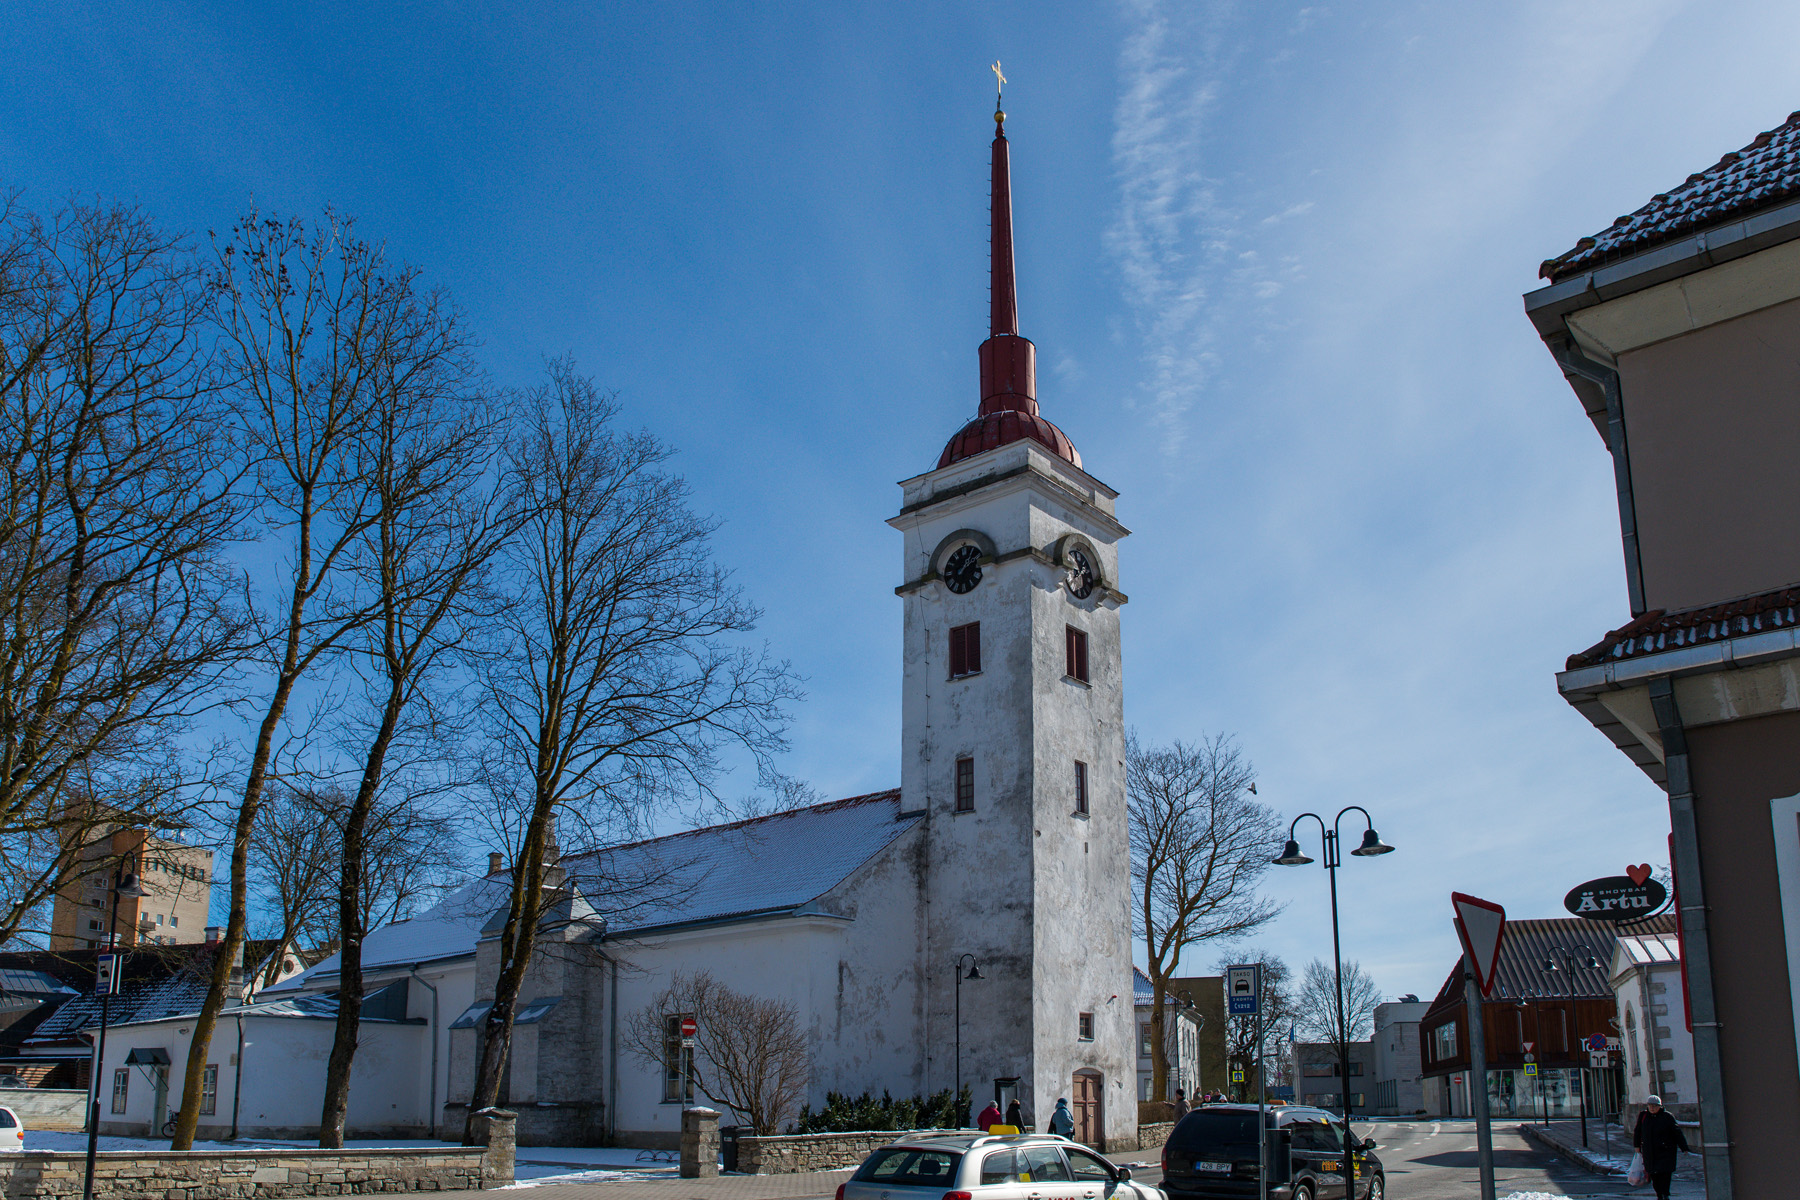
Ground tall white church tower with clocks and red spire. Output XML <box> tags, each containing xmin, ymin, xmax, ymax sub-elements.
<box><xmin>889</xmin><ymin>91</ymin><xmax>1138</xmax><ymax>1148</ymax></box>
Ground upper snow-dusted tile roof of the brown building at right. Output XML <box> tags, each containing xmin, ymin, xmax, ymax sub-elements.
<box><xmin>1537</xmin><ymin>112</ymin><xmax>1800</xmax><ymax>281</ymax></box>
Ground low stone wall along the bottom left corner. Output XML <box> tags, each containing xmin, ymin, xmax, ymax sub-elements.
<box><xmin>0</xmin><ymin>1148</ymin><xmax>513</xmax><ymax>1200</ymax></box>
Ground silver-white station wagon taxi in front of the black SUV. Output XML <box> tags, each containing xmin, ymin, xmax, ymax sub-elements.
<box><xmin>837</xmin><ymin>1133</ymin><xmax>1168</xmax><ymax>1200</ymax></box>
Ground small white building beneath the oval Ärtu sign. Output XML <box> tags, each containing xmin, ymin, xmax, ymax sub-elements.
<box><xmin>1607</xmin><ymin>934</ymin><xmax>1699</xmax><ymax>1124</ymax></box>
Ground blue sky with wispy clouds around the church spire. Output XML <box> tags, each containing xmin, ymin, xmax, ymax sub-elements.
<box><xmin>14</xmin><ymin>0</ymin><xmax>1800</xmax><ymax>995</ymax></box>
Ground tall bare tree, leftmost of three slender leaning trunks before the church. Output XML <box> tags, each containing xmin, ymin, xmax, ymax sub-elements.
<box><xmin>173</xmin><ymin>210</ymin><xmax>418</xmax><ymax>1150</ymax></box>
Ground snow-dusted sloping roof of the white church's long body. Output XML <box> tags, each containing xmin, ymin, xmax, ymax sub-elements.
<box><xmin>273</xmin><ymin>788</ymin><xmax>920</xmax><ymax>997</ymax></box>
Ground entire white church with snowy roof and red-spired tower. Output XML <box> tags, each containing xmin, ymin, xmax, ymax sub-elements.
<box><xmin>87</xmin><ymin>105</ymin><xmax>1138</xmax><ymax>1148</ymax></box>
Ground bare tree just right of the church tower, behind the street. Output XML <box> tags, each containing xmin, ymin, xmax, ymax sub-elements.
<box><xmin>1125</xmin><ymin>734</ymin><xmax>1282</xmax><ymax>1099</ymax></box>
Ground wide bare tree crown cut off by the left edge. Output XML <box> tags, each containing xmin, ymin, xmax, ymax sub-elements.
<box><xmin>0</xmin><ymin>198</ymin><xmax>243</xmax><ymax>943</ymax></box>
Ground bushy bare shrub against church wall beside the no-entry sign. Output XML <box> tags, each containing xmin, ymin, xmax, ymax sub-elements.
<box><xmin>625</xmin><ymin>972</ymin><xmax>812</xmax><ymax>1137</ymax></box>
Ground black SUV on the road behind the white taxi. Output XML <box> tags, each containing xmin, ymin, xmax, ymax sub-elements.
<box><xmin>1163</xmin><ymin>1105</ymin><xmax>1388</xmax><ymax>1200</ymax></box>
